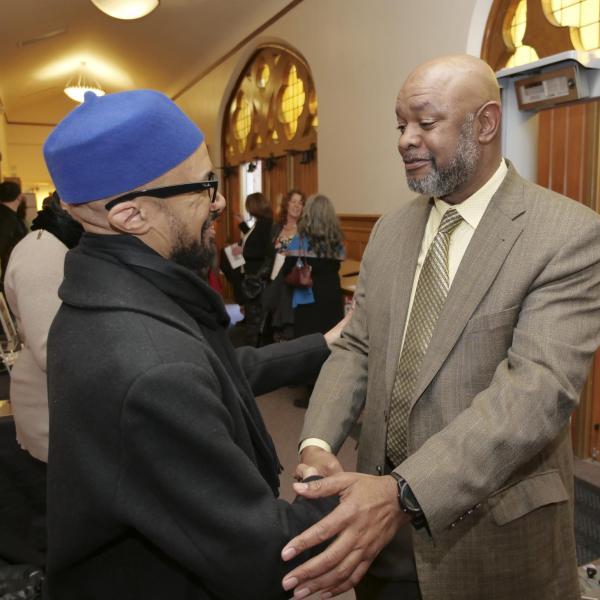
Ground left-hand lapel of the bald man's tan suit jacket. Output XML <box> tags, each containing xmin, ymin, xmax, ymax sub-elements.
<box><xmin>385</xmin><ymin>196</ymin><xmax>433</xmax><ymax>400</ymax></box>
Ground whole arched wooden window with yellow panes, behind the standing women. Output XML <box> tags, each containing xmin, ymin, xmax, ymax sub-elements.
<box><xmin>222</xmin><ymin>45</ymin><xmax>319</xmax><ymax>241</ymax></box>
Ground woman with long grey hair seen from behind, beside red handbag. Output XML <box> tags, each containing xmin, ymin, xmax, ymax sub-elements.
<box><xmin>282</xmin><ymin>194</ymin><xmax>345</xmax><ymax>337</ymax></box>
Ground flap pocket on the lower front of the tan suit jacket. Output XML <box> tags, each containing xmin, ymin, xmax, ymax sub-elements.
<box><xmin>488</xmin><ymin>470</ymin><xmax>569</xmax><ymax>525</ymax></box>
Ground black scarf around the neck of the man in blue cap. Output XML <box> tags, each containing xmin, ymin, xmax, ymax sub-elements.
<box><xmin>78</xmin><ymin>233</ymin><xmax>281</xmax><ymax>495</ymax></box>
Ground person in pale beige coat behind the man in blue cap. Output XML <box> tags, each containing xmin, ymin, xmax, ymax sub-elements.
<box><xmin>4</xmin><ymin>193</ymin><xmax>83</xmax><ymax>462</ymax></box>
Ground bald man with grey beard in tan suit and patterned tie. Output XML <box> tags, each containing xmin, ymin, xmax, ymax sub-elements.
<box><xmin>283</xmin><ymin>56</ymin><xmax>600</xmax><ymax>600</ymax></box>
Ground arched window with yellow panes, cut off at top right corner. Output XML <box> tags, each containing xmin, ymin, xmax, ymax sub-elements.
<box><xmin>481</xmin><ymin>0</ymin><xmax>600</xmax><ymax>70</ymax></box>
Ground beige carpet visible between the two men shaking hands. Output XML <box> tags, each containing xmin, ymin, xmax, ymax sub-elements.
<box><xmin>258</xmin><ymin>387</ymin><xmax>356</xmax><ymax>600</ymax></box>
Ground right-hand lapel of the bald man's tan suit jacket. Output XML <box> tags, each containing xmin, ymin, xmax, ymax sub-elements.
<box><xmin>413</xmin><ymin>165</ymin><xmax>526</xmax><ymax>404</ymax></box>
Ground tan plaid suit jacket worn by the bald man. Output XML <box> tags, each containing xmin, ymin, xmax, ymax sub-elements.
<box><xmin>302</xmin><ymin>165</ymin><xmax>600</xmax><ymax>600</ymax></box>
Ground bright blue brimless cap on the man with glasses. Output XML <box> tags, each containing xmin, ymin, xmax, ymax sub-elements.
<box><xmin>44</xmin><ymin>90</ymin><xmax>204</xmax><ymax>204</ymax></box>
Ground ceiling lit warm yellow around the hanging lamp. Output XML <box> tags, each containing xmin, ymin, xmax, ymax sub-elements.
<box><xmin>0</xmin><ymin>0</ymin><xmax>291</xmax><ymax>124</ymax></box>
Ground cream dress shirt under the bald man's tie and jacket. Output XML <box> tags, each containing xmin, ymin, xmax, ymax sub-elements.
<box><xmin>299</xmin><ymin>160</ymin><xmax>508</xmax><ymax>452</ymax></box>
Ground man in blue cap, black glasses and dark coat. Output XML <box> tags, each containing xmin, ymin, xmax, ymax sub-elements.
<box><xmin>44</xmin><ymin>90</ymin><xmax>342</xmax><ymax>600</ymax></box>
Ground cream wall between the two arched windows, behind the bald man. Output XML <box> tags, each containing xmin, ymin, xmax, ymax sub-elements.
<box><xmin>177</xmin><ymin>0</ymin><xmax>480</xmax><ymax>214</ymax></box>
